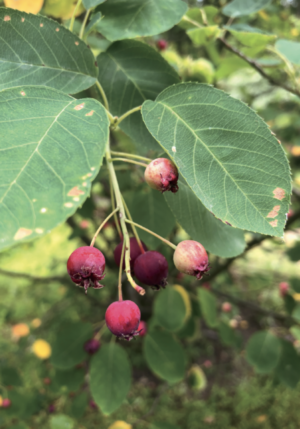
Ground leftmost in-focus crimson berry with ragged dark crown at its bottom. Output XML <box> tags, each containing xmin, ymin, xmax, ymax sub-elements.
<box><xmin>67</xmin><ymin>246</ymin><xmax>105</xmax><ymax>293</ymax></box>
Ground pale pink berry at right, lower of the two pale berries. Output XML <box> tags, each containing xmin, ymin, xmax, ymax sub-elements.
<box><xmin>173</xmin><ymin>240</ymin><xmax>209</xmax><ymax>280</ymax></box>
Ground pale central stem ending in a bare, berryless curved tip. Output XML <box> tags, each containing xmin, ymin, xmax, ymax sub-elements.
<box><xmin>105</xmin><ymin>145</ymin><xmax>146</xmax><ymax>295</ymax></box>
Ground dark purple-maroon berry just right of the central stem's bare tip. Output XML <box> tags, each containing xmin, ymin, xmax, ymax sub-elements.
<box><xmin>133</xmin><ymin>250</ymin><xmax>168</xmax><ymax>290</ymax></box>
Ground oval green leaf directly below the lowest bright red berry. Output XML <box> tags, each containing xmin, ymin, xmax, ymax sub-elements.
<box><xmin>90</xmin><ymin>343</ymin><xmax>131</xmax><ymax>415</ymax></box>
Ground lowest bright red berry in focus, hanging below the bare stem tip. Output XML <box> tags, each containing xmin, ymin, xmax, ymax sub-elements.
<box><xmin>105</xmin><ymin>300</ymin><xmax>141</xmax><ymax>341</ymax></box>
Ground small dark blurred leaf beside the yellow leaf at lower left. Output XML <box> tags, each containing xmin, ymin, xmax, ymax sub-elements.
<box><xmin>51</xmin><ymin>322</ymin><xmax>93</xmax><ymax>369</ymax></box>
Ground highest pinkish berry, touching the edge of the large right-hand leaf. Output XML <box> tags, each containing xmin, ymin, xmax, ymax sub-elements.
<box><xmin>145</xmin><ymin>158</ymin><xmax>178</xmax><ymax>192</ymax></box>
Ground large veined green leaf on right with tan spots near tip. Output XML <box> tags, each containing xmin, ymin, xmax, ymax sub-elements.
<box><xmin>142</xmin><ymin>83</ymin><xmax>291</xmax><ymax>236</ymax></box>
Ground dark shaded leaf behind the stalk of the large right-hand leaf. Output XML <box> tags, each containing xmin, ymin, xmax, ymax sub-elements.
<box><xmin>97</xmin><ymin>40</ymin><xmax>180</xmax><ymax>152</ymax></box>
